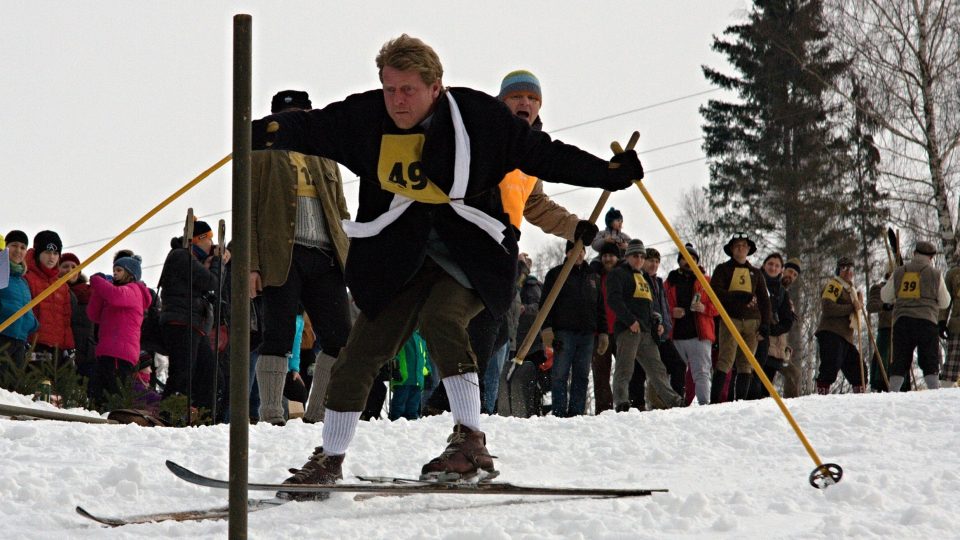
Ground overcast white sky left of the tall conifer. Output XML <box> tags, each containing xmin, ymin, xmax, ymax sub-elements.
<box><xmin>0</xmin><ymin>0</ymin><xmax>747</xmax><ymax>285</ymax></box>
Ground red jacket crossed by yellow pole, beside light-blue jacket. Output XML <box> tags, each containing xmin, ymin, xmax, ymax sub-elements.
<box><xmin>25</xmin><ymin>249</ymin><xmax>75</xmax><ymax>350</ymax></box>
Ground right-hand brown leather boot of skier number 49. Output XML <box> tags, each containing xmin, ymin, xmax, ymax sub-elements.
<box><xmin>420</xmin><ymin>424</ymin><xmax>500</xmax><ymax>482</ymax></box>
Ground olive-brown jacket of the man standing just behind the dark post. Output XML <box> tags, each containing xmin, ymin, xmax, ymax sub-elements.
<box><xmin>250</xmin><ymin>150</ymin><xmax>350</xmax><ymax>287</ymax></box>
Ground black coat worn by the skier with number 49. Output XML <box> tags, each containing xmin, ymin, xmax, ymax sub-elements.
<box><xmin>253</xmin><ymin>88</ymin><xmax>609</xmax><ymax>317</ymax></box>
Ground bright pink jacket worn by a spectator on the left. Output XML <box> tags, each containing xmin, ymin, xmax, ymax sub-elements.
<box><xmin>87</xmin><ymin>274</ymin><xmax>151</xmax><ymax>365</ymax></box>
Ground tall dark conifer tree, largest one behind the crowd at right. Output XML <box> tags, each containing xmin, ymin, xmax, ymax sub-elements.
<box><xmin>701</xmin><ymin>0</ymin><xmax>854</xmax><ymax>257</ymax></box>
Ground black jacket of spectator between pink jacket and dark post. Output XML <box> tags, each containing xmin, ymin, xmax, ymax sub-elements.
<box><xmin>160</xmin><ymin>239</ymin><xmax>220</xmax><ymax>329</ymax></box>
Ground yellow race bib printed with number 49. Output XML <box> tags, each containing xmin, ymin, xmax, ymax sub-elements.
<box><xmin>377</xmin><ymin>133</ymin><xmax>450</xmax><ymax>204</ymax></box>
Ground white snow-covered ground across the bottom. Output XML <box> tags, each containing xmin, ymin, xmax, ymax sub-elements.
<box><xmin>0</xmin><ymin>389</ymin><xmax>960</xmax><ymax>540</ymax></box>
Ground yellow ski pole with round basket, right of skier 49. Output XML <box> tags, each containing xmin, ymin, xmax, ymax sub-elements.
<box><xmin>610</xmin><ymin>135</ymin><xmax>843</xmax><ymax>489</ymax></box>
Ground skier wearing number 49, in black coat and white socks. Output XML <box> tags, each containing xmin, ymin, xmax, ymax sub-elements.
<box><xmin>253</xmin><ymin>35</ymin><xmax>643</xmax><ymax>497</ymax></box>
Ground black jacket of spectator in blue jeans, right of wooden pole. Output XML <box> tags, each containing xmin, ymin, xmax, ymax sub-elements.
<box><xmin>540</xmin><ymin>262</ymin><xmax>607</xmax><ymax>333</ymax></box>
